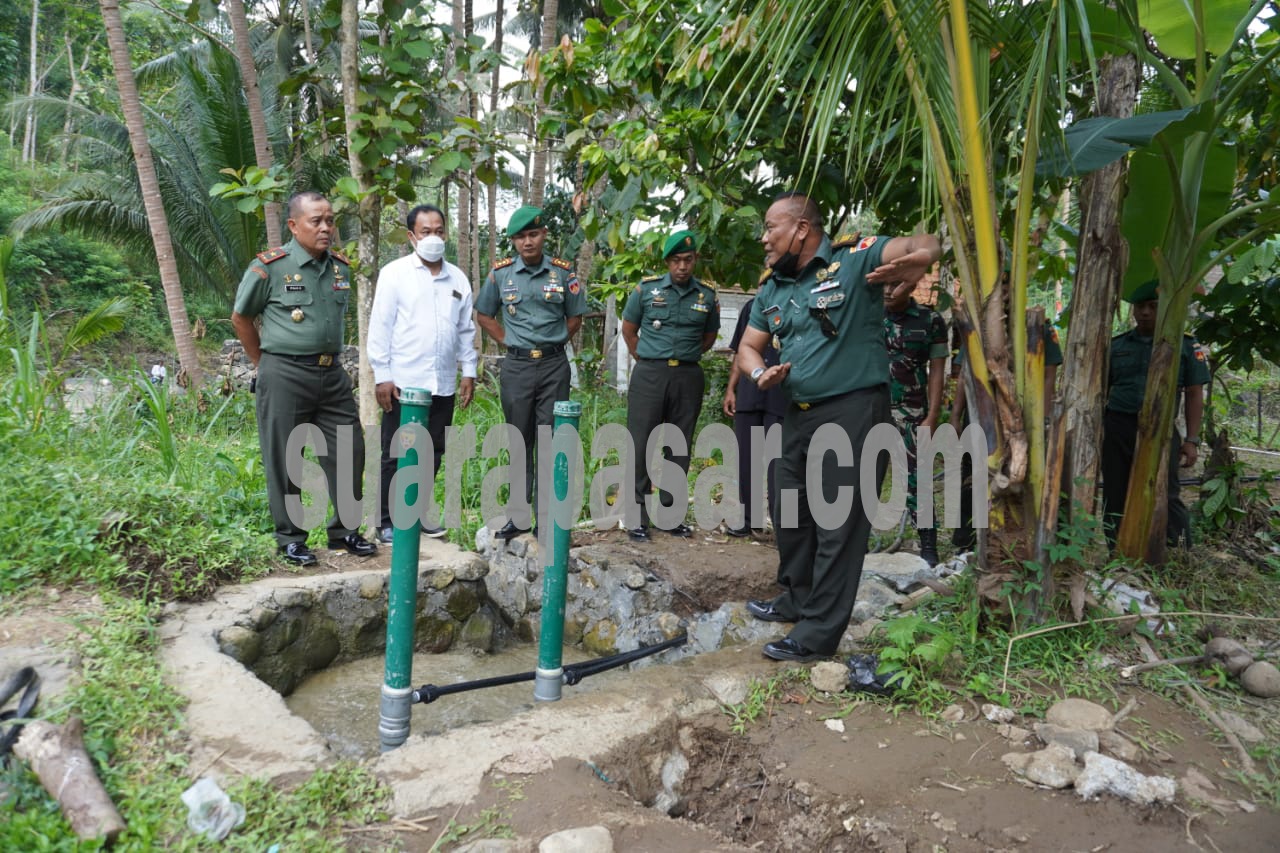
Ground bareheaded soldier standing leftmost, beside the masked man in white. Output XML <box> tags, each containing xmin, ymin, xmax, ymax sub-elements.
<box><xmin>232</xmin><ymin>192</ymin><xmax>378</xmax><ymax>566</ymax></box>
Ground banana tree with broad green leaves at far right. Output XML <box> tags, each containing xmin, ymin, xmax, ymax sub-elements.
<box><xmin>1100</xmin><ymin>0</ymin><xmax>1280</xmax><ymax>562</ymax></box>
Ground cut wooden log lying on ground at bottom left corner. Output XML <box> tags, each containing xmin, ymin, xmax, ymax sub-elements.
<box><xmin>13</xmin><ymin>717</ymin><xmax>124</xmax><ymax>843</ymax></box>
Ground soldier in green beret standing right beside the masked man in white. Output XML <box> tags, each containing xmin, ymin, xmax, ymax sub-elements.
<box><xmin>476</xmin><ymin>205</ymin><xmax>586</xmax><ymax>539</ymax></box>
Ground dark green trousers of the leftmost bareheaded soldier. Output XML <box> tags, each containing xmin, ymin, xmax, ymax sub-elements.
<box><xmin>255</xmin><ymin>352</ymin><xmax>365</xmax><ymax>546</ymax></box>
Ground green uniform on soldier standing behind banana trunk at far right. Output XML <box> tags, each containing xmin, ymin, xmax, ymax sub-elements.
<box><xmin>1102</xmin><ymin>312</ymin><xmax>1210</xmax><ymax>547</ymax></box>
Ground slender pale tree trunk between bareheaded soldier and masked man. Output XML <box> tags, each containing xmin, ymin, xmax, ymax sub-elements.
<box><xmin>339</xmin><ymin>0</ymin><xmax>381</xmax><ymax>425</ymax></box>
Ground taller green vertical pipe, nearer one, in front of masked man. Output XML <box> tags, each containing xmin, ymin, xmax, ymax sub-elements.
<box><xmin>378</xmin><ymin>388</ymin><xmax>431</xmax><ymax>752</ymax></box>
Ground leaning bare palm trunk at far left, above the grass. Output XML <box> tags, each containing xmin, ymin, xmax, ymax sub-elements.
<box><xmin>99</xmin><ymin>0</ymin><xmax>205</xmax><ymax>388</ymax></box>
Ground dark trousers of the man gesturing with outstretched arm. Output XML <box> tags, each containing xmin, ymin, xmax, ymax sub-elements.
<box><xmin>773</xmin><ymin>386</ymin><xmax>892</xmax><ymax>654</ymax></box>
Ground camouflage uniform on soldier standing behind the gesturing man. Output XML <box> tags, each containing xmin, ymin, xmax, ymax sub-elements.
<box><xmin>884</xmin><ymin>300</ymin><xmax>948</xmax><ymax>524</ymax></box>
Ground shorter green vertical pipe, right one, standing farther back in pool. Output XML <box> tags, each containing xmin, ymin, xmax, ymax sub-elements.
<box><xmin>534</xmin><ymin>400</ymin><xmax>582</xmax><ymax>702</ymax></box>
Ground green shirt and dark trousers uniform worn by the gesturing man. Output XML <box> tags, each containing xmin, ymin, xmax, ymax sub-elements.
<box><xmin>750</xmin><ymin>234</ymin><xmax>891</xmax><ymax>654</ymax></box>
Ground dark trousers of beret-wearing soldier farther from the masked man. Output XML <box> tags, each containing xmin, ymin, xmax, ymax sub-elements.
<box><xmin>627</xmin><ymin>361</ymin><xmax>707</xmax><ymax>526</ymax></box>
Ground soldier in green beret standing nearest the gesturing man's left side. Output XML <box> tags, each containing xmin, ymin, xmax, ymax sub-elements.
<box><xmin>622</xmin><ymin>231</ymin><xmax>719</xmax><ymax>542</ymax></box>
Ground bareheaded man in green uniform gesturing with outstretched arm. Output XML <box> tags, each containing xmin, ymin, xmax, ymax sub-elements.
<box><xmin>737</xmin><ymin>192</ymin><xmax>942</xmax><ymax>661</ymax></box>
